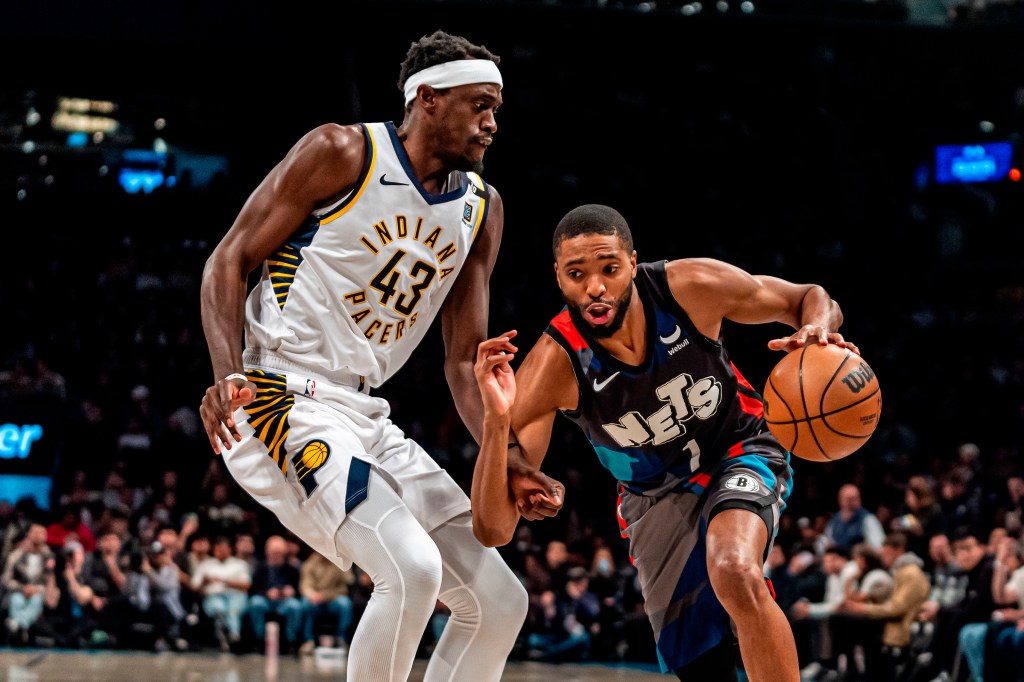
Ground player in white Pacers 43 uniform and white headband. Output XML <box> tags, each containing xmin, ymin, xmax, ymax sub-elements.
<box><xmin>201</xmin><ymin>32</ymin><xmax>554</xmax><ymax>682</ymax></box>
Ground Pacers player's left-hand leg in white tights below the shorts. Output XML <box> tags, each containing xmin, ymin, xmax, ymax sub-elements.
<box><xmin>332</xmin><ymin>471</ymin><xmax>441</xmax><ymax>682</ymax></box>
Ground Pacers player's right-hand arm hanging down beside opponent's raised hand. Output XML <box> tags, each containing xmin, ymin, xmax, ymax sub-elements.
<box><xmin>441</xmin><ymin>185</ymin><xmax>505</xmax><ymax>443</ymax></box>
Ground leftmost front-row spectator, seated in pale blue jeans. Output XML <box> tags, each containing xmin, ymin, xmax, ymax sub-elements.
<box><xmin>0</xmin><ymin>523</ymin><xmax>54</xmax><ymax>644</ymax></box>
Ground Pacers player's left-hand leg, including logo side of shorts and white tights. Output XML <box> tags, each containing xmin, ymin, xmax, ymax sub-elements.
<box><xmin>223</xmin><ymin>382</ymin><xmax>441</xmax><ymax>682</ymax></box>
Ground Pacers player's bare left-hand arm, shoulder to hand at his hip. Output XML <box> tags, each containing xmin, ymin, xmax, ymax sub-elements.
<box><xmin>200</xmin><ymin>125</ymin><xmax>366</xmax><ymax>455</ymax></box>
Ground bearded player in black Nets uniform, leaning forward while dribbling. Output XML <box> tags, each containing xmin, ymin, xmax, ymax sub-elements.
<box><xmin>471</xmin><ymin>205</ymin><xmax>858</xmax><ymax>682</ymax></box>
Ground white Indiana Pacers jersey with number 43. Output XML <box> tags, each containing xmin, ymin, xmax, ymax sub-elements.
<box><xmin>244</xmin><ymin>122</ymin><xmax>487</xmax><ymax>386</ymax></box>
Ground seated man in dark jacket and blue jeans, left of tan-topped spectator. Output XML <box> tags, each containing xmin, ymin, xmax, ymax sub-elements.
<box><xmin>249</xmin><ymin>536</ymin><xmax>302</xmax><ymax>651</ymax></box>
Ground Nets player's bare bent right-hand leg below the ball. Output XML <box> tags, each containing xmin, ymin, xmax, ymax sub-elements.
<box><xmin>702</xmin><ymin>441</ymin><xmax>800</xmax><ymax>682</ymax></box>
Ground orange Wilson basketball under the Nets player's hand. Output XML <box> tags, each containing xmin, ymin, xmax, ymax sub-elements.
<box><xmin>764</xmin><ymin>343</ymin><xmax>882</xmax><ymax>462</ymax></box>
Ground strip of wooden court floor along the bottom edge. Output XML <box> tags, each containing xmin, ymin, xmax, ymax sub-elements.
<box><xmin>0</xmin><ymin>649</ymin><xmax>675</xmax><ymax>682</ymax></box>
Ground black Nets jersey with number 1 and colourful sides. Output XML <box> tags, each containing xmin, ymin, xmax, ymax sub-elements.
<box><xmin>545</xmin><ymin>261</ymin><xmax>778</xmax><ymax>496</ymax></box>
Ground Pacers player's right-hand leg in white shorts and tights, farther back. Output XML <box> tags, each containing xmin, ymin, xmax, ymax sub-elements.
<box><xmin>378</xmin><ymin>425</ymin><xmax>528</xmax><ymax>682</ymax></box>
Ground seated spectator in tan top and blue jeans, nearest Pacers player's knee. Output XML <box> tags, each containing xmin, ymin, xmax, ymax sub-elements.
<box><xmin>299</xmin><ymin>551</ymin><xmax>355</xmax><ymax>654</ymax></box>
